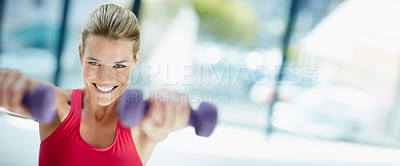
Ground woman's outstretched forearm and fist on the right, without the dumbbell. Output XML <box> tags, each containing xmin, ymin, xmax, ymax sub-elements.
<box><xmin>132</xmin><ymin>90</ymin><xmax>190</xmax><ymax>165</ymax></box>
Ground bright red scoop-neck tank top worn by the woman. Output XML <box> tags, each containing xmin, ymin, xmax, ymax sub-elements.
<box><xmin>39</xmin><ymin>89</ymin><xmax>143</xmax><ymax>166</ymax></box>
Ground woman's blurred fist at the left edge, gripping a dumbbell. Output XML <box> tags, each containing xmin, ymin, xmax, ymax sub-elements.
<box><xmin>0</xmin><ymin>69</ymin><xmax>38</xmax><ymax>118</ymax></box>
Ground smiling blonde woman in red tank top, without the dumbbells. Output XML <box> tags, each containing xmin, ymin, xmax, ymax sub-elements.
<box><xmin>0</xmin><ymin>4</ymin><xmax>190</xmax><ymax>166</ymax></box>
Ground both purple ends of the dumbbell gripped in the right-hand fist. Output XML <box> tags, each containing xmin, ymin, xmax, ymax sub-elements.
<box><xmin>119</xmin><ymin>89</ymin><xmax>217</xmax><ymax>137</ymax></box>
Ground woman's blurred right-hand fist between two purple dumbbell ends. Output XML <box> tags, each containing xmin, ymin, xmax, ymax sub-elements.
<box><xmin>140</xmin><ymin>89</ymin><xmax>190</xmax><ymax>143</ymax></box>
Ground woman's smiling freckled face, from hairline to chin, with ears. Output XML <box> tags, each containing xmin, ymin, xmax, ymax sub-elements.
<box><xmin>79</xmin><ymin>36</ymin><xmax>139</xmax><ymax>106</ymax></box>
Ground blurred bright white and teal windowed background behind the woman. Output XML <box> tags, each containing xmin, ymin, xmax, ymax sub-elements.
<box><xmin>0</xmin><ymin>0</ymin><xmax>400</xmax><ymax>166</ymax></box>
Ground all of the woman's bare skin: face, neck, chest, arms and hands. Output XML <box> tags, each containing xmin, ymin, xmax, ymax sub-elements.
<box><xmin>0</xmin><ymin>36</ymin><xmax>190</xmax><ymax>164</ymax></box>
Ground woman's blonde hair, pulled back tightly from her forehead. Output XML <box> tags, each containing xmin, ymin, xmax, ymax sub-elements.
<box><xmin>80</xmin><ymin>4</ymin><xmax>140</xmax><ymax>59</ymax></box>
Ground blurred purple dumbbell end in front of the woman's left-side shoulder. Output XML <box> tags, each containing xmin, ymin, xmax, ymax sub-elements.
<box><xmin>22</xmin><ymin>85</ymin><xmax>56</xmax><ymax>124</ymax></box>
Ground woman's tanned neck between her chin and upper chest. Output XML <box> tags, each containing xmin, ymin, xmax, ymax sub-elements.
<box><xmin>82</xmin><ymin>89</ymin><xmax>118</xmax><ymax>122</ymax></box>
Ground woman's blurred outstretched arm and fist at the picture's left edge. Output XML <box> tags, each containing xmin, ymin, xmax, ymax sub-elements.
<box><xmin>0</xmin><ymin>69</ymin><xmax>72</xmax><ymax>140</ymax></box>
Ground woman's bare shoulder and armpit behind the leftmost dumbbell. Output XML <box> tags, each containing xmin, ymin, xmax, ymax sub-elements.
<box><xmin>39</xmin><ymin>85</ymin><xmax>72</xmax><ymax>141</ymax></box>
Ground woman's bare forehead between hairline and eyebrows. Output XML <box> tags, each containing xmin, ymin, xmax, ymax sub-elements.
<box><xmin>84</xmin><ymin>36</ymin><xmax>133</xmax><ymax>60</ymax></box>
